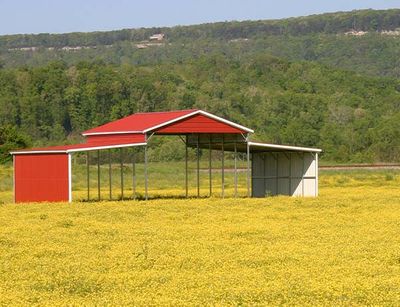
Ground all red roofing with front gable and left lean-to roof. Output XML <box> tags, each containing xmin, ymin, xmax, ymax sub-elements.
<box><xmin>11</xmin><ymin>110</ymin><xmax>253</xmax><ymax>154</ymax></box>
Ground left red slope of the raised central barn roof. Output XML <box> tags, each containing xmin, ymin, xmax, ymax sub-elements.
<box><xmin>82</xmin><ymin>110</ymin><xmax>198</xmax><ymax>135</ymax></box>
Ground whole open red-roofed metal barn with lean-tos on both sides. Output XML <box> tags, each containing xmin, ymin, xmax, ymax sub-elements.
<box><xmin>11</xmin><ymin>110</ymin><xmax>320</xmax><ymax>202</ymax></box>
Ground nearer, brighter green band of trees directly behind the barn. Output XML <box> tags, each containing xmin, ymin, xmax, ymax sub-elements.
<box><xmin>0</xmin><ymin>55</ymin><xmax>400</xmax><ymax>162</ymax></box>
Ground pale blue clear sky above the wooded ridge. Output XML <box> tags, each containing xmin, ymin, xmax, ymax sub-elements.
<box><xmin>0</xmin><ymin>0</ymin><xmax>400</xmax><ymax>35</ymax></box>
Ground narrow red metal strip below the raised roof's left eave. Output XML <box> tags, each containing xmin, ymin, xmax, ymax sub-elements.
<box><xmin>86</xmin><ymin>133</ymin><xmax>146</xmax><ymax>146</ymax></box>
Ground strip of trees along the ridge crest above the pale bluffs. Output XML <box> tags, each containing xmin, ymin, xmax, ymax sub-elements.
<box><xmin>0</xmin><ymin>9</ymin><xmax>400</xmax><ymax>48</ymax></box>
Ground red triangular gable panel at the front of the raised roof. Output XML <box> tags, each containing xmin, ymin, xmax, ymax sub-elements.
<box><xmin>156</xmin><ymin>114</ymin><xmax>245</xmax><ymax>134</ymax></box>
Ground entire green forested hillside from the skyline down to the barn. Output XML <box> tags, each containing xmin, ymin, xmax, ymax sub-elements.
<box><xmin>0</xmin><ymin>10</ymin><xmax>400</xmax><ymax>162</ymax></box>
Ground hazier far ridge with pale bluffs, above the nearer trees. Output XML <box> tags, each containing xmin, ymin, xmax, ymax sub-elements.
<box><xmin>0</xmin><ymin>9</ymin><xmax>400</xmax><ymax>77</ymax></box>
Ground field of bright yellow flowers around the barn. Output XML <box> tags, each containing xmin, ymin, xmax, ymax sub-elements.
<box><xmin>0</xmin><ymin>170</ymin><xmax>400</xmax><ymax>306</ymax></box>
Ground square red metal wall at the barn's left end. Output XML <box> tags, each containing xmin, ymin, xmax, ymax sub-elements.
<box><xmin>14</xmin><ymin>154</ymin><xmax>69</xmax><ymax>202</ymax></box>
